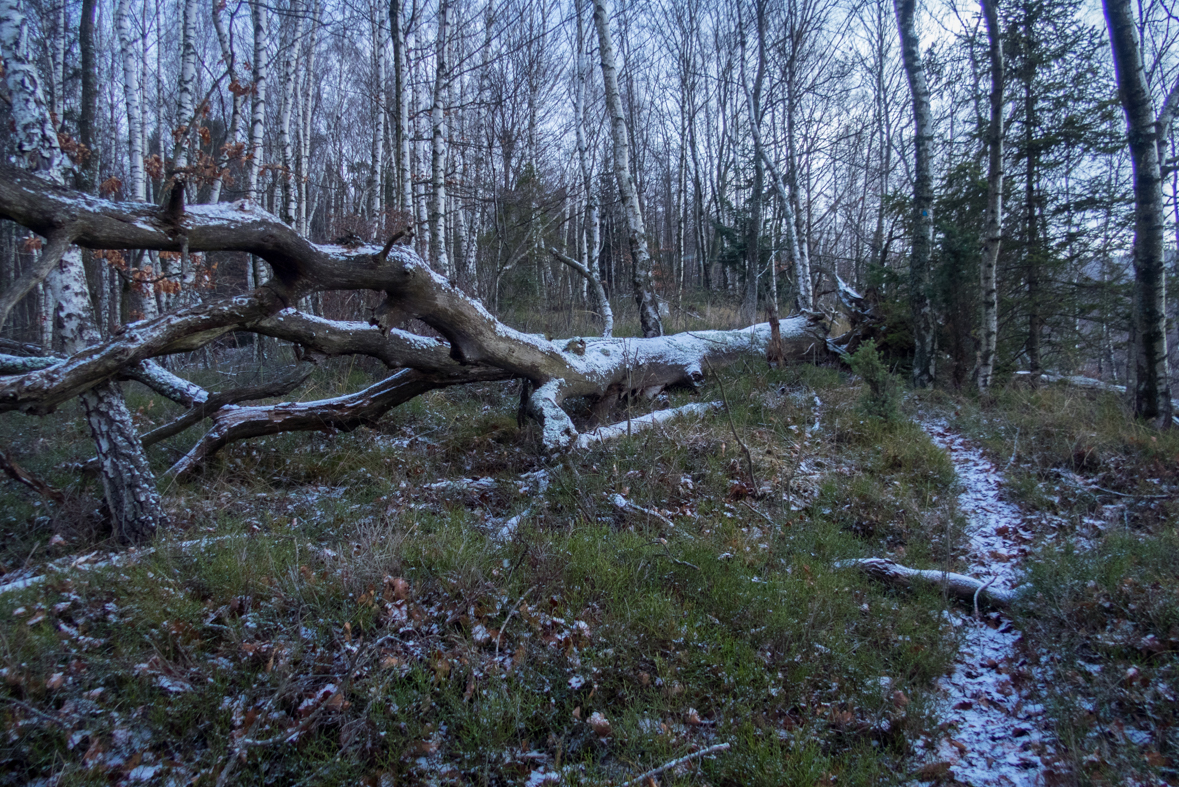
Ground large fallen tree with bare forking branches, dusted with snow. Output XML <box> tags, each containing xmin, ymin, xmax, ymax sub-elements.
<box><xmin>0</xmin><ymin>164</ymin><xmax>829</xmax><ymax>541</ymax></box>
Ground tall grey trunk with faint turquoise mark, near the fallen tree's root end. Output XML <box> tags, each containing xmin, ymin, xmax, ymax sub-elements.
<box><xmin>894</xmin><ymin>0</ymin><xmax>934</xmax><ymax>388</ymax></box>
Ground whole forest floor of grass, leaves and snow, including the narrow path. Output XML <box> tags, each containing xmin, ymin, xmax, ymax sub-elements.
<box><xmin>0</xmin><ymin>353</ymin><xmax>1179</xmax><ymax>786</ymax></box>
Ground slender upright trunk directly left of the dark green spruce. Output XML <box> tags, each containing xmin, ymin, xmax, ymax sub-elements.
<box><xmin>979</xmin><ymin>0</ymin><xmax>1005</xmax><ymax>394</ymax></box>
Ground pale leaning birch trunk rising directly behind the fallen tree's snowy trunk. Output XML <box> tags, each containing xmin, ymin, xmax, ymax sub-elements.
<box><xmin>593</xmin><ymin>0</ymin><xmax>663</xmax><ymax>338</ymax></box>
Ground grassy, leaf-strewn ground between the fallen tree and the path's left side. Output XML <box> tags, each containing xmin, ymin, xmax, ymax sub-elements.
<box><xmin>0</xmin><ymin>363</ymin><xmax>971</xmax><ymax>785</ymax></box>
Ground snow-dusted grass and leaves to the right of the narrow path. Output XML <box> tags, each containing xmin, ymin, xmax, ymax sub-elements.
<box><xmin>956</xmin><ymin>386</ymin><xmax>1179</xmax><ymax>785</ymax></box>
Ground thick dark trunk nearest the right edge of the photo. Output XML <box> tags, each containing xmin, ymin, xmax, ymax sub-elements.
<box><xmin>1105</xmin><ymin>0</ymin><xmax>1171</xmax><ymax>426</ymax></box>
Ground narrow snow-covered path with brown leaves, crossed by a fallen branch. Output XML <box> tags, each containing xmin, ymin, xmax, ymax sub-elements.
<box><xmin>914</xmin><ymin>421</ymin><xmax>1055</xmax><ymax>787</ymax></box>
